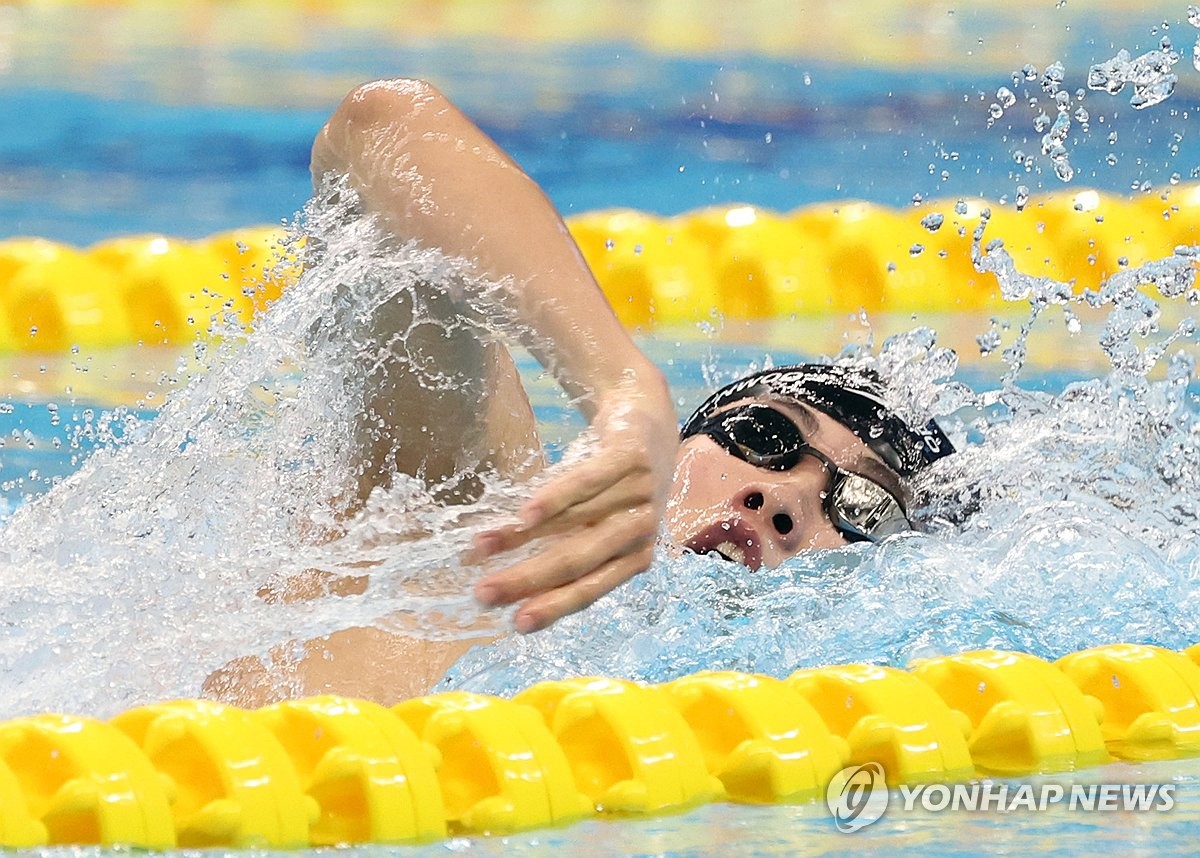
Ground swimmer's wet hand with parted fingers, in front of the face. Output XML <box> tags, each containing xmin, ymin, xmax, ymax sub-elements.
<box><xmin>473</xmin><ymin>370</ymin><xmax>679</xmax><ymax>632</ymax></box>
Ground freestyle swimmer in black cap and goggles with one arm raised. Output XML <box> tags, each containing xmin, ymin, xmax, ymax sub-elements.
<box><xmin>205</xmin><ymin>79</ymin><xmax>952</xmax><ymax>706</ymax></box>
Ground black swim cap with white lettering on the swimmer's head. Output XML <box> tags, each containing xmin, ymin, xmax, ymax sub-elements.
<box><xmin>679</xmin><ymin>364</ymin><xmax>954</xmax><ymax>476</ymax></box>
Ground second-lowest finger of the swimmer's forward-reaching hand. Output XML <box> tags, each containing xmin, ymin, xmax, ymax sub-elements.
<box><xmin>475</xmin><ymin>508</ymin><xmax>658</xmax><ymax>610</ymax></box>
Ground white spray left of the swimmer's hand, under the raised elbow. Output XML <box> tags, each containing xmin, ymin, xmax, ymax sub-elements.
<box><xmin>0</xmin><ymin>187</ymin><xmax>554</xmax><ymax>718</ymax></box>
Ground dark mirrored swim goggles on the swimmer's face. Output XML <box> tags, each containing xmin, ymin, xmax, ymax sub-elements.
<box><xmin>686</xmin><ymin>402</ymin><xmax>913</xmax><ymax>542</ymax></box>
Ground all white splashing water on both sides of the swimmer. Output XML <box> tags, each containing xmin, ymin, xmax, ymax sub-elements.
<box><xmin>0</xmin><ymin>189</ymin><xmax>1200</xmax><ymax>716</ymax></box>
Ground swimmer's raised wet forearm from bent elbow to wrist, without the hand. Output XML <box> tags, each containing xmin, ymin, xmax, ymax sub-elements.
<box><xmin>312</xmin><ymin>80</ymin><xmax>662</xmax><ymax>419</ymax></box>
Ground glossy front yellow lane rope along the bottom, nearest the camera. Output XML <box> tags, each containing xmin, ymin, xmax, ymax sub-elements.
<box><xmin>0</xmin><ymin>644</ymin><xmax>1200</xmax><ymax>850</ymax></box>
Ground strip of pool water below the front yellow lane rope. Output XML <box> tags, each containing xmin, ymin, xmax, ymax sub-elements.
<box><xmin>343</xmin><ymin>762</ymin><xmax>1200</xmax><ymax>856</ymax></box>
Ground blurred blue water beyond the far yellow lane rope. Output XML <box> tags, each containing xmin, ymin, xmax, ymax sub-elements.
<box><xmin>7</xmin><ymin>4</ymin><xmax>1200</xmax><ymax>244</ymax></box>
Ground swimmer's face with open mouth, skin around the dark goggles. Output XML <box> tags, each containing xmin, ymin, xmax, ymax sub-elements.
<box><xmin>664</xmin><ymin>400</ymin><xmax>906</xmax><ymax>569</ymax></box>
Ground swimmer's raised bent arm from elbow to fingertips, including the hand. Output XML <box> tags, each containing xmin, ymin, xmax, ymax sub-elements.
<box><xmin>313</xmin><ymin>80</ymin><xmax>677</xmax><ymax>631</ymax></box>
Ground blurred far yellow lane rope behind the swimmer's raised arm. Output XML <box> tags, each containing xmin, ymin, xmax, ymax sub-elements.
<box><xmin>0</xmin><ymin>185</ymin><xmax>1200</xmax><ymax>352</ymax></box>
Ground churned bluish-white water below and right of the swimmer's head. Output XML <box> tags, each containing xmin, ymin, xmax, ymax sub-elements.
<box><xmin>442</xmin><ymin>216</ymin><xmax>1200</xmax><ymax>694</ymax></box>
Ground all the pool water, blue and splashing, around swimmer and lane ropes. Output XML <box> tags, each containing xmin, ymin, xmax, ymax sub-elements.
<box><xmin>0</xmin><ymin>0</ymin><xmax>1200</xmax><ymax>854</ymax></box>
